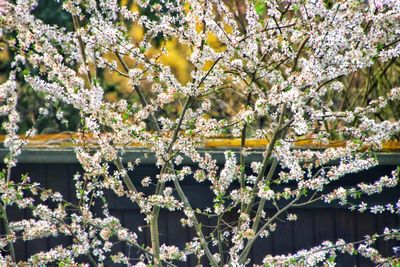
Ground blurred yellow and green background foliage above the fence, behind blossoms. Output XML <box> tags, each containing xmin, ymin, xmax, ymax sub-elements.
<box><xmin>0</xmin><ymin>0</ymin><xmax>400</xmax><ymax>138</ymax></box>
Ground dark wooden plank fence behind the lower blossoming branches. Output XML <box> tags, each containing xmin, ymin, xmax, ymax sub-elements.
<box><xmin>0</xmin><ymin>151</ymin><xmax>400</xmax><ymax>266</ymax></box>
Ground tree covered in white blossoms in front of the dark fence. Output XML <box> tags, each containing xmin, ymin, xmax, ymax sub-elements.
<box><xmin>0</xmin><ymin>0</ymin><xmax>400</xmax><ymax>266</ymax></box>
